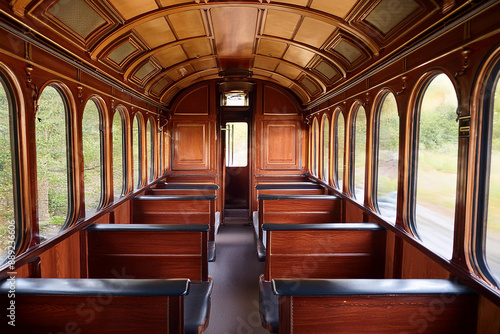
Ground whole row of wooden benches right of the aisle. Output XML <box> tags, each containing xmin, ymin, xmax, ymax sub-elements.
<box><xmin>254</xmin><ymin>179</ymin><xmax>477</xmax><ymax>334</ymax></box>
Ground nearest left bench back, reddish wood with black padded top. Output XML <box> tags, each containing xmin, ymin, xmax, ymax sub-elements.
<box><xmin>0</xmin><ymin>278</ymin><xmax>190</xmax><ymax>334</ymax></box>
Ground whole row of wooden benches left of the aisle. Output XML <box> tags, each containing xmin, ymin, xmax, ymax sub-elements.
<box><xmin>0</xmin><ymin>183</ymin><xmax>219</xmax><ymax>334</ymax></box>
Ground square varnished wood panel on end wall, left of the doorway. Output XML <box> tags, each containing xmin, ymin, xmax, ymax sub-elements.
<box><xmin>172</xmin><ymin>121</ymin><xmax>211</xmax><ymax>170</ymax></box>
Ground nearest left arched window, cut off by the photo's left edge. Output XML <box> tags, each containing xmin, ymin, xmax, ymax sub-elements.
<box><xmin>0</xmin><ymin>72</ymin><xmax>21</xmax><ymax>265</ymax></box>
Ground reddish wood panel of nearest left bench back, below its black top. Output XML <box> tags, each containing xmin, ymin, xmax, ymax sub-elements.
<box><xmin>0</xmin><ymin>291</ymin><xmax>184</xmax><ymax>334</ymax></box>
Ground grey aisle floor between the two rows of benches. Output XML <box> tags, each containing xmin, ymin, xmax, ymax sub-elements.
<box><xmin>205</xmin><ymin>219</ymin><xmax>269</xmax><ymax>334</ymax></box>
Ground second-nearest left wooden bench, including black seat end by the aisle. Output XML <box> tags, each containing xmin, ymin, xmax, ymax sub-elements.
<box><xmin>86</xmin><ymin>224</ymin><xmax>212</xmax><ymax>334</ymax></box>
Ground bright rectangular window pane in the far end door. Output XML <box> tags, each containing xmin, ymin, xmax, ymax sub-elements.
<box><xmin>226</xmin><ymin>122</ymin><xmax>248</xmax><ymax>167</ymax></box>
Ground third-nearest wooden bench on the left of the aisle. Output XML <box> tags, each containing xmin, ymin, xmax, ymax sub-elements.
<box><xmin>131</xmin><ymin>195</ymin><xmax>217</xmax><ymax>261</ymax></box>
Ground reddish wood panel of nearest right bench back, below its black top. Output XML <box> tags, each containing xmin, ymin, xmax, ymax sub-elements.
<box><xmin>286</xmin><ymin>295</ymin><xmax>477</xmax><ymax>334</ymax></box>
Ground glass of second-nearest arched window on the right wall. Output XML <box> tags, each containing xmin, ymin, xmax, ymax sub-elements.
<box><xmin>415</xmin><ymin>74</ymin><xmax>458</xmax><ymax>258</ymax></box>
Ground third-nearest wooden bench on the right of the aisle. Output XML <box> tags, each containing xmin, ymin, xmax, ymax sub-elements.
<box><xmin>254</xmin><ymin>194</ymin><xmax>342</xmax><ymax>261</ymax></box>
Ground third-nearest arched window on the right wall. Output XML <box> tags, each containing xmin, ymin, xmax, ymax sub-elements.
<box><xmin>375</xmin><ymin>92</ymin><xmax>399</xmax><ymax>223</ymax></box>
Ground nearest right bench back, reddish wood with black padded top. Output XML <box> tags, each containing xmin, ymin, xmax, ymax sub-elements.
<box><xmin>273</xmin><ymin>279</ymin><xmax>478</xmax><ymax>334</ymax></box>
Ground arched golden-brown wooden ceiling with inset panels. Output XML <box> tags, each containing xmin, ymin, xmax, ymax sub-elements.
<box><xmin>12</xmin><ymin>0</ymin><xmax>439</xmax><ymax>105</ymax></box>
